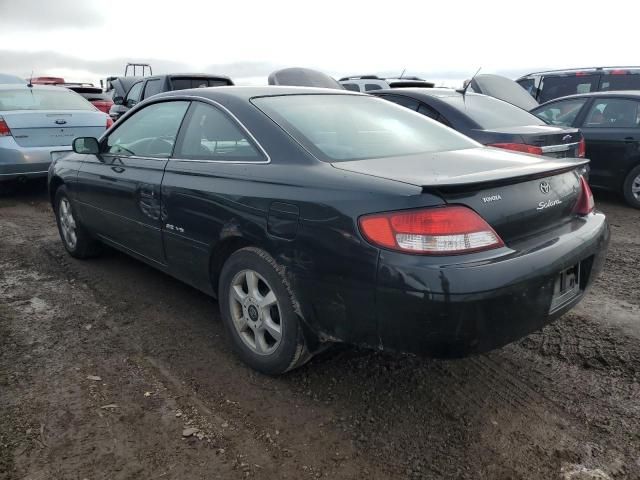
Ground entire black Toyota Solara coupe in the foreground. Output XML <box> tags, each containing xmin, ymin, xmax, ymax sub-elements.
<box><xmin>49</xmin><ymin>87</ymin><xmax>609</xmax><ymax>374</ymax></box>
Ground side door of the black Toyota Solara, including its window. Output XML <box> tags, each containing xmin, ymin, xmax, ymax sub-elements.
<box><xmin>78</xmin><ymin>100</ymin><xmax>189</xmax><ymax>263</ymax></box>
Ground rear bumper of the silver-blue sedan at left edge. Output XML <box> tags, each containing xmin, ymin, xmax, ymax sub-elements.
<box><xmin>0</xmin><ymin>137</ymin><xmax>71</xmax><ymax>182</ymax></box>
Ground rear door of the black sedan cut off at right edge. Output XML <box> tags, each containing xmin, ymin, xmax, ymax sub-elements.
<box><xmin>579</xmin><ymin>96</ymin><xmax>640</xmax><ymax>190</ymax></box>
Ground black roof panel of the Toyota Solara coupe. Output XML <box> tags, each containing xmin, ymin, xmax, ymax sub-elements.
<box><xmin>152</xmin><ymin>85</ymin><xmax>360</xmax><ymax>100</ymax></box>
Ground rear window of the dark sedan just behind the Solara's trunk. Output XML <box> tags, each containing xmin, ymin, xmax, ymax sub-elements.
<box><xmin>440</xmin><ymin>94</ymin><xmax>545</xmax><ymax>130</ymax></box>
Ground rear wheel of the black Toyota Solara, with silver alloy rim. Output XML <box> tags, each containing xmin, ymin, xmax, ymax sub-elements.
<box><xmin>218</xmin><ymin>247</ymin><xmax>310</xmax><ymax>375</ymax></box>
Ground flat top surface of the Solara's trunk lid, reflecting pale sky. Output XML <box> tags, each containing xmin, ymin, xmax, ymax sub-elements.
<box><xmin>332</xmin><ymin>147</ymin><xmax>589</xmax><ymax>187</ymax></box>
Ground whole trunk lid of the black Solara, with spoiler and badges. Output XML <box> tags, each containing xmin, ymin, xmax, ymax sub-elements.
<box><xmin>333</xmin><ymin>148</ymin><xmax>588</xmax><ymax>243</ymax></box>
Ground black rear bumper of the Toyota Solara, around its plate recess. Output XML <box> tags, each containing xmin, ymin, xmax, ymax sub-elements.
<box><xmin>376</xmin><ymin>213</ymin><xmax>609</xmax><ymax>357</ymax></box>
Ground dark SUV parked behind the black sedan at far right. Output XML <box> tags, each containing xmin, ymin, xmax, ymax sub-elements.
<box><xmin>516</xmin><ymin>67</ymin><xmax>640</xmax><ymax>103</ymax></box>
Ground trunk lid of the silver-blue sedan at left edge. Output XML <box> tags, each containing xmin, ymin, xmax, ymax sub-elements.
<box><xmin>0</xmin><ymin>110</ymin><xmax>107</xmax><ymax>147</ymax></box>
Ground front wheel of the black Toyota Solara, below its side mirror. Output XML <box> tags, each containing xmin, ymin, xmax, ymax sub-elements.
<box><xmin>53</xmin><ymin>185</ymin><xmax>101</xmax><ymax>258</ymax></box>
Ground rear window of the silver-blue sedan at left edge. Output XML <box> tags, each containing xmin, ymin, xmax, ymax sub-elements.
<box><xmin>0</xmin><ymin>88</ymin><xmax>95</xmax><ymax>112</ymax></box>
